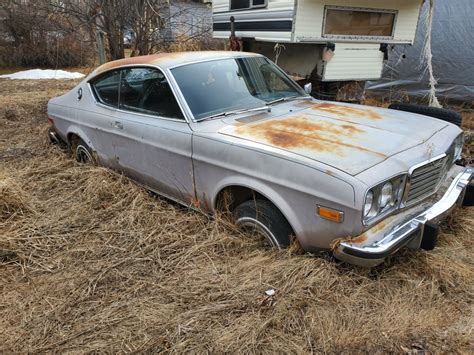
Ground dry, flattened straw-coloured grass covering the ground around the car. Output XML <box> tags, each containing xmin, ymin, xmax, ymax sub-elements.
<box><xmin>0</xmin><ymin>80</ymin><xmax>474</xmax><ymax>353</ymax></box>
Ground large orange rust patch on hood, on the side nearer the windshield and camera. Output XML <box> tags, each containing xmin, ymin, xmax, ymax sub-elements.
<box><xmin>235</xmin><ymin>115</ymin><xmax>385</xmax><ymax>157</ymax></box>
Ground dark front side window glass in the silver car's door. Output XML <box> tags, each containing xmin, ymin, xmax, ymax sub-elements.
<box><xmin>119</xmin><ymin>68</ymin><xmax>184</xmax><ymax>120</ymax></box>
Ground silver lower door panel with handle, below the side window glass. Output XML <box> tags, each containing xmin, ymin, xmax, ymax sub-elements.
<box><xmin>114</xmin><ymin>111</ymin><xmax>194</xmax><ymax>204</ymax></box>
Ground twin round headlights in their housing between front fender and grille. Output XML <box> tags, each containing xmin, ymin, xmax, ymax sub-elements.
<box><xmin>363</xmin><ymin>175</ymin><xmax>406</xmax><ymax>225</ymax></box>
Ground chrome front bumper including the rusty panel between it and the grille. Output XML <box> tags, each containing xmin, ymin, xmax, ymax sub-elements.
<box><xmin>334</xmin><ymin>167</ymin><xmax>474</xmax><ymax>267</ymax></box>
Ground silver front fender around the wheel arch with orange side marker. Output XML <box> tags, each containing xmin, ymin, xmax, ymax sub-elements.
<box><xmin>193</xmin><ymin>136</ymin><xmax>365</xmax><ymax>251</ymax></box>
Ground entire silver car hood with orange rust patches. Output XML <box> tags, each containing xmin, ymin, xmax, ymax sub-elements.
<box><xmin>219</xmin><ymin>101</ymin><xmax>447</xmax><ymax>175</ymax></box>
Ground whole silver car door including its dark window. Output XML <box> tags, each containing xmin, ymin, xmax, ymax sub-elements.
<box><xmin>111</xmin><ymin>67</ymin><xmax>194</xmax><ymax>204</ymax></box>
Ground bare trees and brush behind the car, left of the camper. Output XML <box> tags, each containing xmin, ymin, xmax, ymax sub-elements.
<box><xmin>0</xmin><ymin>0</ymin><xmax>218</xmax><ymax>67</ymax></box>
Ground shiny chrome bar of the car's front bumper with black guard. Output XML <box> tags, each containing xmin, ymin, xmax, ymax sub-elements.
<box><xmin>334</xmin><ymin>167</ymin><xmax>474</xmax><ymax>267</ymax></box>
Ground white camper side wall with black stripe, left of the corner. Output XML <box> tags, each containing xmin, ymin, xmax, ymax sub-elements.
<box><xmin>212</xmin><ymin>0</ymin><xmax>295</xmax><ymax>42</ymax></box>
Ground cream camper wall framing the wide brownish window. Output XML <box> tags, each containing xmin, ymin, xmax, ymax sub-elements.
<box><xmin>295</xmin><ymin>0</ymin><xmax>421</xmax><ymax>44</ymax></box>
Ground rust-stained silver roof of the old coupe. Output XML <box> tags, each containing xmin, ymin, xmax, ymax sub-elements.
<box><xmin>93</xmin><ymin>51</ymin><xmax>260</xmax><ymax>76</ymax></box>
